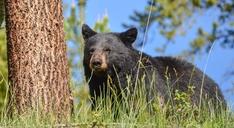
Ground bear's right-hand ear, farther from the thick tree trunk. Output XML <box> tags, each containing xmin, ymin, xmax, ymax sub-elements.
<box><xmin>120</xmin><ymin>28</ymin><xmax>137</xmax><ymax>47</ymax></box>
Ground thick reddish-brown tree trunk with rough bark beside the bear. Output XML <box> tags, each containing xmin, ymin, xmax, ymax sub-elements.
<box><xmin>5</xmin><ymin>0</ymin><xmax>72</xmax><ymax>118</ymax></box>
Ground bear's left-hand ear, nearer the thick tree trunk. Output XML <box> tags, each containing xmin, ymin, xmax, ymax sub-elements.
<box><xmin>82</xmin><ymin>24</ymin><xmax>97</xmax><ymax>41</ymax></box>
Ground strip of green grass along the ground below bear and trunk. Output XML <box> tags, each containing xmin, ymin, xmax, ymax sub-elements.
<box><xmin>0</xmin><ymin>76</ymin><xmax>234</xmax><ymax>128</ymax></box>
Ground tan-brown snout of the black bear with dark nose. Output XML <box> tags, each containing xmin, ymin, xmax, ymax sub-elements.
<box><xmin>89</xmin><ymin>54</ymin><xmax>107</xmax><ymax>72</ymax></box>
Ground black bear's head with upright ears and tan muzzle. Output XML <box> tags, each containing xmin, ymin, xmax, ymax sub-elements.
<box><xmin>82</xmin><ymin>24</ymin><xmax>137</xmax><ymax>75</ymax></box>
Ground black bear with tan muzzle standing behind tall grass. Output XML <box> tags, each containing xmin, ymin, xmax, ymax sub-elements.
<box><xmin>82</xmin><ymin>24</ymin><xmax>226</xmax><ymax>111</ymax></box>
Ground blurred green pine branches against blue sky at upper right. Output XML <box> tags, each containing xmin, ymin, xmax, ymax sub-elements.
<box><xmin>123</xmin><ymin>0</ymin><xmax>234</xmax><ymax>57</ymax></box>
